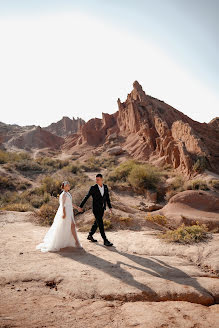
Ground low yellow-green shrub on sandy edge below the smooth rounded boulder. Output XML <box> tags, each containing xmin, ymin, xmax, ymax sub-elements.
<box><xmin>160</xmin><ymin>223</ymin><xmax>208</xmax><ymax>244</ymax></box>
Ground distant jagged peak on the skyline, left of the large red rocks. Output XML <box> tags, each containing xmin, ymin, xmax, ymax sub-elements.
<box><xmin>44</xmin><ymin>116</ymin><xmax>85</xmax><ymax>137</ymax></box>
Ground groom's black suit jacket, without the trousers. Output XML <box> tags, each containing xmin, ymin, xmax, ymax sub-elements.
<box><xmin>80</xmin><ymin>184</ymin><xmax>112</xmax><ymax>212</ymax></box>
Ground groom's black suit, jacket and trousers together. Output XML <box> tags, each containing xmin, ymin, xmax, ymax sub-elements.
<box><xmin>80</xmin><ymin>184</ymin><xmax>112</xmax><ymax>240</ymax></box>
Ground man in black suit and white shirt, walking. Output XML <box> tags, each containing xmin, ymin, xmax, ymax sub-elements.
<box><xmin>80</xmin><ymin>173</ymin><xmax>113</xmax><ymax>246</ymax></box>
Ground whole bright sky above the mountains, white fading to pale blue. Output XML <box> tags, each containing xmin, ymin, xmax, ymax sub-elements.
<box><xmin>0</xmin><ymin>0</ymin><xmax>219</xmax><ymax>126</ymax></box>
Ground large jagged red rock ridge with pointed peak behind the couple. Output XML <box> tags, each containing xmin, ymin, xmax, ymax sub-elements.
<box><xmin>65</xmin><ymin>81</ymin><xmax>219</xmax><ymax>174</ymax></box>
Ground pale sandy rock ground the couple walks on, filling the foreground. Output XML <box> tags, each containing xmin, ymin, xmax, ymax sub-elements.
<box><xmin>0</xmin><ymin>211</ymin><xmax>219</xmax><ymax>328</ymax></box>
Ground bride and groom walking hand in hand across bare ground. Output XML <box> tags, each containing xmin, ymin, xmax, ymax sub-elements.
<box><xmin>36</xmin><ymin>173</ymin><xmax>113</xmax><ymax>252</ymax></box>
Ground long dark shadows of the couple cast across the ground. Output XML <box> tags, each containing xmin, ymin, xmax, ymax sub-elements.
<box><xmin>59</xmin><ymin>243</ymin><xmax>210</xmax><ymax>301</ymax></box>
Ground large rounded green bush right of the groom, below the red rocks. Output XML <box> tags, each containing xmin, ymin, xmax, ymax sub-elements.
<box><xmin>128</xmin><ymin>165</ymin><xmax>161</xmax><ymax>190</ymax></box>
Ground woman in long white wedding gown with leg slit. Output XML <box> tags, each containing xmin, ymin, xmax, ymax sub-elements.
<box><xmin>36</xmin><ymin>181</ymin><xmax>82</xmax><ymax>252</ymax></box>
